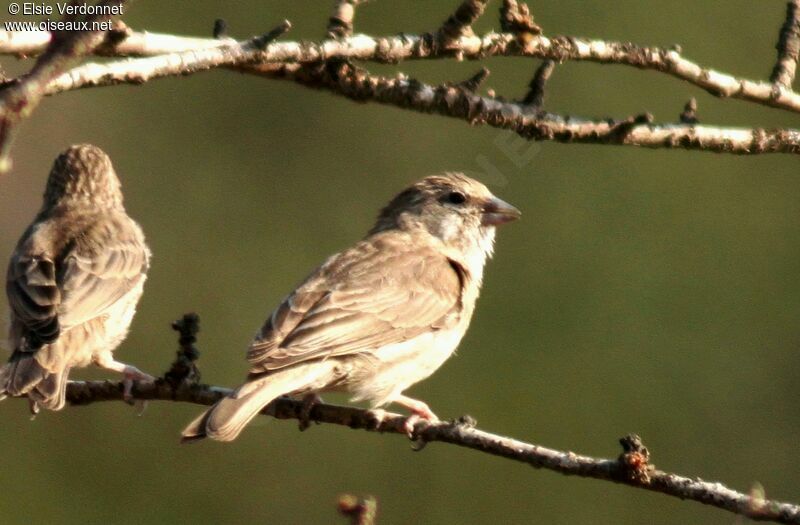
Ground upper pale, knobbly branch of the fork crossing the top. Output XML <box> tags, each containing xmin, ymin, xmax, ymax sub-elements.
<box><xmin>9</xmin><ymin>31</ymin><xmax>800</xmax><ymax>112</ymax></box>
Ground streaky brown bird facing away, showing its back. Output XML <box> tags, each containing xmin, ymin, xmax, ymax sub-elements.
<box><xmin>0</xmin><ymin>144</ymin><xmax>152</xmax><ymax>413</ymax></box>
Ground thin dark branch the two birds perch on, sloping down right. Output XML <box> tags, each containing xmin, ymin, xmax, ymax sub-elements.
<box><xmin>56</xmin><ymin>380</ymin><xmax>800</xmax><ymax>524</ymax></box>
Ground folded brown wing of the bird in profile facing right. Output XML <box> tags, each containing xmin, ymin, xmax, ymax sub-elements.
<box><xmin>248</xmin><ymin>236</ymin><xmax>463</xmax><ymax>373</ymax></box>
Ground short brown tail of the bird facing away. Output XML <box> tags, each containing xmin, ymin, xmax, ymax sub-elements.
<box><xmin>0</xmin><ymin>350</ymin><xmax>69</xmax><ymax>410</ymax></box>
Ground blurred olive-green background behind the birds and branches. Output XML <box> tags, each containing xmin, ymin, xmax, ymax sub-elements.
<box><xmin>0</xmin><ymin>0</ymin><xmax>800</xmax><ymax>524</ymax></box>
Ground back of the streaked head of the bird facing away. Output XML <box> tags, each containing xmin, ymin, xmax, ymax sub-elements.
<box><xmin>44</xmin><ymin>144</ymin><xmax>122</xmax><ymax>208</ymax></box>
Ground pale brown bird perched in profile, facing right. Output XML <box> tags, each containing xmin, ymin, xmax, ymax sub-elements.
<box><xmin>181</xmin><ymin>172</ymin><xmax>521</xmax><ymax>443</ymax></box>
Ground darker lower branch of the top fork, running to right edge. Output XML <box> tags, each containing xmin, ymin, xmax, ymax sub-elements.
<box><xmin>262</xmin><ymin>64</ymin><xmax>800</xmax><ymax>154</ymax></box>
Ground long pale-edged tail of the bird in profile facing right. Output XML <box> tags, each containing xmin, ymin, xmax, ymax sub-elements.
<box><xmin>181</xmin><ymin>359</ymin><xmax>337</xmax><ymax>443</ymax></box>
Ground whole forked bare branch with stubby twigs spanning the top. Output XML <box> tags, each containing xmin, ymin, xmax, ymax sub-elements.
<box><xmin>0</xmin><ymin>0</ymin><xmax>800</xmax><ymax>165</ymax></box>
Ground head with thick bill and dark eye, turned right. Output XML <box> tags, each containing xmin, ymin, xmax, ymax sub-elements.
<box><xmin>370</xmin><ymin>173</ymin><xmax>520</xmax><ymax>255</ymax></box>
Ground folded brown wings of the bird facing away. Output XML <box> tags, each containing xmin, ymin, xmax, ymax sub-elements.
<box><xmin>6</xmin><ymin>217</ymin><xmax>149</xmax><ymax>350</ymax></box>
